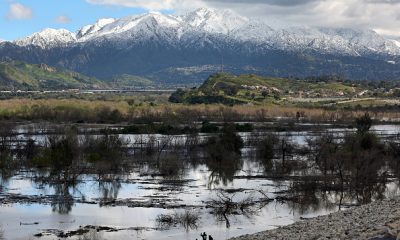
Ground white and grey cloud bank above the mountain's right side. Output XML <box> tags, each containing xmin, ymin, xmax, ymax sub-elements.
<box><xmin>86</xmin><ymin>0</ymin><xmax>400</xmax><ymax>37</ymax></box>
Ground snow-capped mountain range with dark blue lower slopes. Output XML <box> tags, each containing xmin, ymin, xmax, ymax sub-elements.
<box><xmin>0</xmin><ymin>8</ymin><xmax>400</xmax><ymax>85</ymax></box>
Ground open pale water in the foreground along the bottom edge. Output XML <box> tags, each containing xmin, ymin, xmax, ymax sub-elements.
<box><xmin>0</xmin><ymin>202</ymin><xmax>334</xmax><ymax>240</ymax></box>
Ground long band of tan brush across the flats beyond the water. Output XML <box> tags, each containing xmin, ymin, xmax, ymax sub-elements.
<box><xmin>0</xmin><ymin>97</ymin><xmax>400</xmax><ymax>123</ymax></box>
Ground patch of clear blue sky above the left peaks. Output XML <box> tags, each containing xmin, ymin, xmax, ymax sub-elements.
<box><xmin>0</xmin><ymin>0</ymin><xmax>155</xmax><ymax>40</ymax></box>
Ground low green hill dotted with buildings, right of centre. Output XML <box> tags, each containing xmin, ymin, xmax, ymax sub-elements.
<box><xmin>170</xmin><ymin>73</ymin><xmax>364</xmax><ymax>104</ymax></box>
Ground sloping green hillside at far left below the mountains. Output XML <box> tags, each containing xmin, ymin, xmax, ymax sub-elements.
<box><xmin>0</xmin><ymin>61</ymin><xmax>107</xmax><ymax>90</ymax></box>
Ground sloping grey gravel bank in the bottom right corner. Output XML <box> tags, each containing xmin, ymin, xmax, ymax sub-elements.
<box><xmin>231</xmin><ymin>199</ymin><xmax>400</xmax><ymax>240</ymax></box>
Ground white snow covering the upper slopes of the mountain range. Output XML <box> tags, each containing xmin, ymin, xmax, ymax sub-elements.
<box><xmin>8</xmin><ymin>8</ymin><xmax>400</xmax><ymax>56</ymax></box>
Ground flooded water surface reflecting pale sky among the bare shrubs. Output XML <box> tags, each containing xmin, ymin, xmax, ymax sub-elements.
<box><xmin>0</xmin><ymin>125</ymin><xmax>399</xmax><ymax>240</ymax></box>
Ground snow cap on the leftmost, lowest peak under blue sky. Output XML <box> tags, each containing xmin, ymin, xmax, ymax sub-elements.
<box><xmin>14</xmin><ymin>28</ymin><xmax>76</xmax><ymax>48</ymax></box>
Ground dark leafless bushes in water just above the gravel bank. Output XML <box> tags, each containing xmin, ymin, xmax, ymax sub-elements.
<box><xmin>309</xmin><ymin>114</ymin><xmax>390</xmax><ymax>199</ymax></box>
